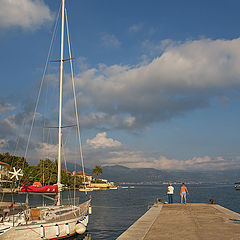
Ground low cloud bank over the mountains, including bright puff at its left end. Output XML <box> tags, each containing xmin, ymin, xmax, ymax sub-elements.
<box><xmin>83</xmin><ymin>132</ymin><xmax>240</xmax><ymax>171</ymax></box>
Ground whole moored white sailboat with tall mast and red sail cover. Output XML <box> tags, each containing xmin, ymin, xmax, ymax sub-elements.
<box><xmin>0</xmin><ymin>0</ymin><xmax>91</xmax><ymax>240</ymax></box>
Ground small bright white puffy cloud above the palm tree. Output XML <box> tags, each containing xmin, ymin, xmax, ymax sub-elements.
<box><xmin>87</xmin><ymin>132</ymin><xmax>122</xmax><ymax>149</ymax></box>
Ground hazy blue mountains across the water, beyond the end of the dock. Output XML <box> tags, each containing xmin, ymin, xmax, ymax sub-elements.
<box><xmin>101</xmin><ymin>165</ymin><xmax>240</xmax><ymax>183</ymax></box>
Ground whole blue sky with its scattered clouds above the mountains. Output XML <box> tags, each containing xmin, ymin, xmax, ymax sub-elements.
<box><xmin>0</xmin><ymin>0</ymin><xmax>240</xmax><ymax>171</ymax></box>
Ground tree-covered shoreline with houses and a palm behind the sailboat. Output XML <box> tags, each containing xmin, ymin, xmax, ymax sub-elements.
<box><xmin>0</xmin><ymin>153</ymin><xmax>121</xmax><ymax>192</ymax></box>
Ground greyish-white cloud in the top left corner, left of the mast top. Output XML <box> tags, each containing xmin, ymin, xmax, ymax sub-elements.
<box><xmin>0</xmin><ymin>0</ymin><xmax>53</xmax><ymax>29</ymax></box>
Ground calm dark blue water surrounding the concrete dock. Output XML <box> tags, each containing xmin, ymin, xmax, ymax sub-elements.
<box><xmin>2</xmin><ymin>184</ymin><xmax>240</xmax><ymax>240</ymax></box>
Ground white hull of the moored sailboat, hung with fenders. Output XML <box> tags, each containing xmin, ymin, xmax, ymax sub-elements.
<box><xmin>0</xmin><ymin>201</ymin><xmax>90</xmax><ymax>240</ymax></box>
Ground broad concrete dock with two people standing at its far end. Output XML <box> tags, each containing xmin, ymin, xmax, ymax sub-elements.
<box><xmin>117</xmin><ymin>203</ymin><xmax>240</xmax><ymax>240</ymax></box>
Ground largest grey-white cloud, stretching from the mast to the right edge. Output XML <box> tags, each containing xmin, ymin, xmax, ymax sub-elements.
<box><xmin>69</xmin><ymin>39</ymin><xmax>240</xmax><ymax>130</ymax></box>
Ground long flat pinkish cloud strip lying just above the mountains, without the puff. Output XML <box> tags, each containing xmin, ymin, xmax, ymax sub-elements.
<box><xmin>93</xmin><ymin>149</ymin><xmax>240</xmax><ymax>171</ymax></box>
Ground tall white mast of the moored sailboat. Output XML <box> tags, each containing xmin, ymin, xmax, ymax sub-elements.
<box><xmin>57</xmin><ymin>0</ymin><xmax>65</xmax><ymax>205</ymax></box>
